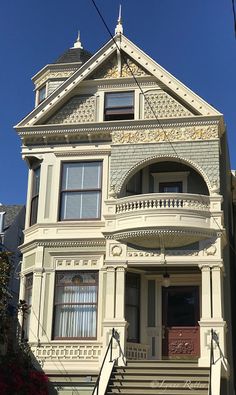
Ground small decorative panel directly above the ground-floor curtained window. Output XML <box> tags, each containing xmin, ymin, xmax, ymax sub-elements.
<box><xmin>54</xmin><ymin>255</ymin><xmax>102</xmax><ymax>269</ymax></box>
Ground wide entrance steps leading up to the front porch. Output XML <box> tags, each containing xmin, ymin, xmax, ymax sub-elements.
<box><xmin>106</xmin><ymin>360</ymin><xmax>209</xmax><ymax>395</ymax></box>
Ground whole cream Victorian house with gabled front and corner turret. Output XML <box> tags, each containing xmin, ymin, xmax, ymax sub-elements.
<box><xmin>16</xmin><ymin>18</ymin><xmax>234</xmax><ymax>395</ymax></box>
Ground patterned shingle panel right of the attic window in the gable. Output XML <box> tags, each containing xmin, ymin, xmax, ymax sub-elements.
<box><xmin>144</xmin><ymin>91</ymin><xmax>193</xmax><ymax>119</ymax></box>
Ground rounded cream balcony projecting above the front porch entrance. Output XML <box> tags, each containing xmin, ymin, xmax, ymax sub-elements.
<box><xmin>103</xmin><ymin>193</ymin><xmax>223</xmax><ymax>248</ymax></box>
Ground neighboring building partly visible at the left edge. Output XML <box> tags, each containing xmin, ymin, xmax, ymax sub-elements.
<box><xmin>0</xmin><ymin>204</ymin><xmax>25</xmax><ymax>309</ymax></box>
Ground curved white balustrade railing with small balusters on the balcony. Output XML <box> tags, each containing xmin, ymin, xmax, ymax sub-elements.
<box><xmin>116</xmin><ymin>193</ymin><xmax>210</xmax><ymax>214</ymax></box>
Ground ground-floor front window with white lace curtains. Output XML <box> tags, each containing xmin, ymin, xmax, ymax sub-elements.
<box><xmin>53</xmin><ymin>271</ymin><xmax>98</xmax><ymax>339</ymax></box>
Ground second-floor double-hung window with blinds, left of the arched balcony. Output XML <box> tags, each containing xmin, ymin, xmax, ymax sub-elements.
<box><xmin>60</xmin><ymin>162</ymin><xmax>102</xmax><ymax>220</ymax></box>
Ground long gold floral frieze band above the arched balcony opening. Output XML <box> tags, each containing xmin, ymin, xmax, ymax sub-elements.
<box><xmin>112</xmin><ymin>125</ymin><xmax>218</xmax><ymax>144</ymax></box>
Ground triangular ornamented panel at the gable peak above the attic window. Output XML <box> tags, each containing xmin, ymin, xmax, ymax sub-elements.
<box><xmin>89</xmin><ymin>54</ymin><xmax>151</xmax><ymax>79</ymax></box>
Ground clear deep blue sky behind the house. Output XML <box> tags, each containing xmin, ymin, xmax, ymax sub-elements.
<box><xmin>0</xmin><ymin>0</ymin><xmax>236</xmax><ymax>204</ymax></box>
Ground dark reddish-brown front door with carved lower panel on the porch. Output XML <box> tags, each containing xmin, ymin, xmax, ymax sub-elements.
<box><xmin>162</xmin><ymin>286</ymin><xmax>200</xmax><ymax>359</ymax></box>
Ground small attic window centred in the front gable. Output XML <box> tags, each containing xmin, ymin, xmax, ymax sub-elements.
<box><xmin>104</xmin><ymin>92</ymin><xmax>134</xmax><ymax>121</ymax></box>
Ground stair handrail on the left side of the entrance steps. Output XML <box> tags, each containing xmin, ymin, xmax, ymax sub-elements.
<box><xmin>92</xmin><ymin>328</ymin><xmax>126</xmax><ymax>395</ymax></box>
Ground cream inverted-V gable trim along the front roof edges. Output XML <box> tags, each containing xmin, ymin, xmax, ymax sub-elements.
<box><xmin>16</xmin><ymin>34</ymin><xmax>222</xmax><ymax>129</ymax></box>
